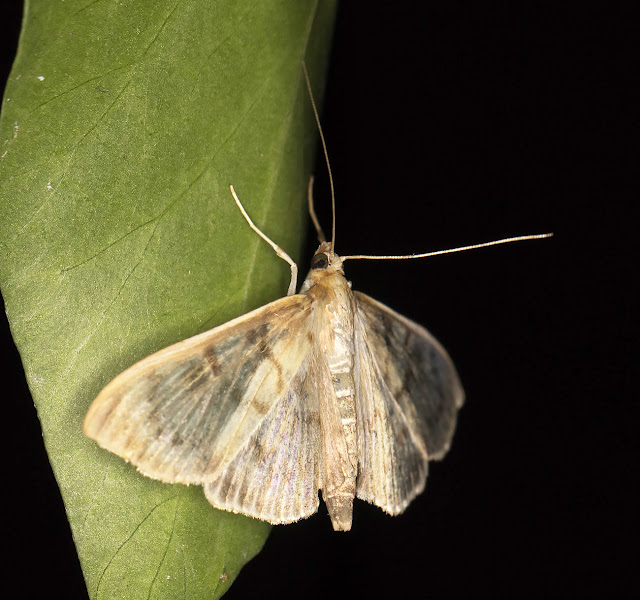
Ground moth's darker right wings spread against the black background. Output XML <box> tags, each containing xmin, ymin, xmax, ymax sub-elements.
<box><xmin>354</xmin><ymin>292</ymin><xmax>464</xmax><ymax>514</ymax></box>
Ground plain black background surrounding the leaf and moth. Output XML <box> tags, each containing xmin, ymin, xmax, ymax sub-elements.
<box><xmin>2</xmin><ymin>0</ymin><xmax>640</xmax><ymax>599</ymax></box>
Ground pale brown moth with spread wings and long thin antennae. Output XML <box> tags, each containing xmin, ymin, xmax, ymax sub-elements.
<box><xmin>84</xmin><ymin>74</ymin><xmax>543</xmax><ymax>531</ymax></box>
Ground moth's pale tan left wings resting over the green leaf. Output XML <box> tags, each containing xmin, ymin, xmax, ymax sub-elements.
<box><xmin>84</xmin><ymin>295</ymin><xmax>319</xmax><ymax>522</ymax></box>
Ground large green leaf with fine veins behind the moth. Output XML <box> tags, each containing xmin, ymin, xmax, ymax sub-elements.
<box><xmin>0</xmin><ymin>0</ymin><xmax>335</xmax><ymax>600</ymax></box>
